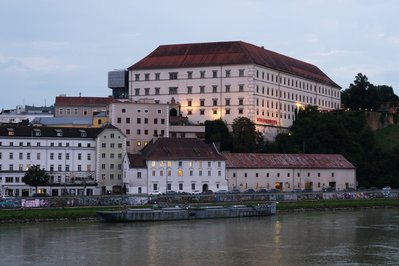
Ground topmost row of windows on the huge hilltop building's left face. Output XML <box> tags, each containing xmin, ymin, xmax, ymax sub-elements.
<box><xmin>134</xmin><ymin>69</ymin><xmax>244</xmax><ymax>81</ymax></box>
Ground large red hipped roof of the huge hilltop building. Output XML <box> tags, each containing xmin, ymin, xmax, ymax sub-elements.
<box><xmin>128</xmin><ymin>41</ymin><xmax>339</xmax><ymax>87</ymax></box>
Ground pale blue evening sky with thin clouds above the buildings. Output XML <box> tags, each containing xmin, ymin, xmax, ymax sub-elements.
<box><xmin>0</xmin><ymin>0</ymin><xmax>399</xmax><ymax>110</ymax></box>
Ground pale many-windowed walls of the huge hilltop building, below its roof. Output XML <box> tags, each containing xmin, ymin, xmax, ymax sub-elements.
<box><xmin>129</xmin><ymin>41</ymin><xmax>341</xmax><ymax>137</ymax></box>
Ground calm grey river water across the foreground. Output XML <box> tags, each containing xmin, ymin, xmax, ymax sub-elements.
<box><xmin>0</xmin><ymin>209</ymin><xmax>399</xmax><ymax>266</ymax></box>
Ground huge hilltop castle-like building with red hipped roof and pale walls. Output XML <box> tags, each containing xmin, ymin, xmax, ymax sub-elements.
<box><xmin>128</xmin><ymin>41</ymin><xmax>341</xmax><ymax>138</ymax></box>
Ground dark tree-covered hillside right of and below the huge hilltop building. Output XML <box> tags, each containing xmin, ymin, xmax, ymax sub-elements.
<box><xmin>206</xmin><ymin>73</ymin><xmax>399</xmax><ymax>188</ymax></box>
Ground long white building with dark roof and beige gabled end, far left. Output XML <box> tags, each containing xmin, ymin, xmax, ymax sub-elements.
<box><xmin>0</xmin><ymin>125</ymin><xmax>126</xmax><ymax>196</ymax></box>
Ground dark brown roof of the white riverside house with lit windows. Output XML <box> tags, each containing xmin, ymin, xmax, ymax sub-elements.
<box><xmin>142</xmin><ymin>138</ymin><xmax>225</xmax><ymax>161</ymax></box>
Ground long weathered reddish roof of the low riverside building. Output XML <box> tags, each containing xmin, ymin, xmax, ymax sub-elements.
<box><xmin>222</xmin><ymin>153</ymin><xmax>355</xmax><ymax>169</ymax></box>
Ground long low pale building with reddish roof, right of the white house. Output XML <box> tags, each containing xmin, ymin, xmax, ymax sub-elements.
<box><xmin>223</xmin><ymin>153</ymin><xmax>357</xmax><ymax>192</ymax></box>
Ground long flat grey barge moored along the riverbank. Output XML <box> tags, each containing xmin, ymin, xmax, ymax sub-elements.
<box><xmin>97</xmin><ymin>202</ymin><xmax>276</xmax><ymax>222</ymax></box>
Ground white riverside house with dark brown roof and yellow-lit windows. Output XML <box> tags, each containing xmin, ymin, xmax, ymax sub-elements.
<box><xmin>123</xmin><ymin>138</ymin><xmax>227</xmax><ymax>194</ymax></box>
